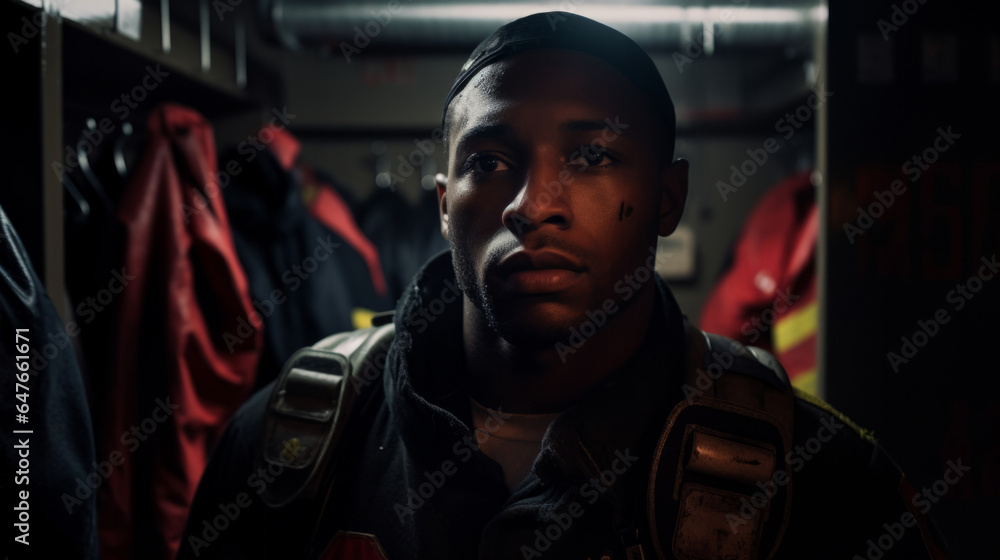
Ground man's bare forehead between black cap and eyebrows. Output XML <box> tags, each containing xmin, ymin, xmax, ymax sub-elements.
<box><xmin>448</xmin><ymin>49</ymin><xmax>657</xmax><ymax>138</ymax></box>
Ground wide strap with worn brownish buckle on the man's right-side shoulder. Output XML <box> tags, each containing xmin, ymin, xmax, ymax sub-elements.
<box><xmin>647</xmin><ymin>325</ymin><xmax>794</xmax><ymax>560</ymax></box>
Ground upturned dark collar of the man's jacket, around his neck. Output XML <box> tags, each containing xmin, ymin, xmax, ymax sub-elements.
<box><xmin>384</xmin><ymin>251</ymin><xmax>685</xmax><ymax>494</ymax></box>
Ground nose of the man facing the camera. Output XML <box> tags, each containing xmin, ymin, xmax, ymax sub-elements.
<box><xmin>502</xmin><ymin>156</ymin><xmax>573</xmax><ymax>236</ymax></box>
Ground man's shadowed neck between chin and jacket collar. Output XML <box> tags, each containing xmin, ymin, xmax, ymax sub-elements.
<box><xmin>462</xmin><ymin>283</ymin><xmax>656</xmax><ymax>414</ymax></box>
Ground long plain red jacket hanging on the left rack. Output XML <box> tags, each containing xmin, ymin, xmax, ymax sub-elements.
<box><xmin>98</xmin><ymin>104</ymin><xmax>262</xmax><ymax>559</ymax></box>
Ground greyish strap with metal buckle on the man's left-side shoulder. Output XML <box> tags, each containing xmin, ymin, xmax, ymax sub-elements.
<box><xmin>255</xmin><ymin>313</ymin><xmax>395</xmax><ymax>557</ymax></box>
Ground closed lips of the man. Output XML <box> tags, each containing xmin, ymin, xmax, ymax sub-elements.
<box><xmin>497</xmin><ymin>251</ymin><xmax>586</xmax><ymax>294</ymax></box>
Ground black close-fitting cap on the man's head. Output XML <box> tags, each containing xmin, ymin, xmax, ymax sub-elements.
<box><xmin>441</xmin><ymin>12</ymin><xmax>676</xmax><ymax>152</ymax></box>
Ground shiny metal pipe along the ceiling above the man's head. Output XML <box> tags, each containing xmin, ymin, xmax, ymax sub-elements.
<box><xmin>261</xmin><ymin>0</ymin><xmax>826</xmax><ymax>54</ymax></box>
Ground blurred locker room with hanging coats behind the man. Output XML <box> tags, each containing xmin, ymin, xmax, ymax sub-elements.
<box><xmin>0</xmin><ymin>0</ymin><xmax>1000</xmax><ymax>558</ymax></box>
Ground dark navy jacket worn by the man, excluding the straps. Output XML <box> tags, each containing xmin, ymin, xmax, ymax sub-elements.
<box><xmin>180</xmin><ymin>253</ymin><xmax>941</xmax><ymax>560</ymax></box>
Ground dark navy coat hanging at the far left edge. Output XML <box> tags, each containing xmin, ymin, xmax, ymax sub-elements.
<box><xmin>0</xmin><ymin>203</ymin><xmax>99</xmax><ymax>560</ymax></box>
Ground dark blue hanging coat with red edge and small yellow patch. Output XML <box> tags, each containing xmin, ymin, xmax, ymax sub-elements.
<box><xmin>223</xmin><ymin>127</ymin><xmax>392</xmax><ymax>387</ymax></box>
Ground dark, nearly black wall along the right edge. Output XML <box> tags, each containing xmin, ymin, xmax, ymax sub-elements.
<box><xmin>823</xmin><ymin>0</ymin><xmax>1000</xmax><ymax>558</ymax></box>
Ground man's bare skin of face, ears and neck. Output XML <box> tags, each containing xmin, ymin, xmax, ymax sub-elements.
<box><xmin>437</xmin><ymin>49</ymin><xmax>688</xmax><ymax>413</ymax></box>
